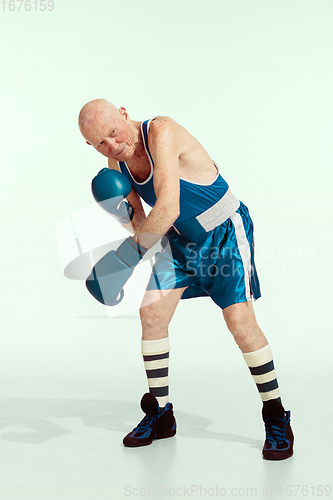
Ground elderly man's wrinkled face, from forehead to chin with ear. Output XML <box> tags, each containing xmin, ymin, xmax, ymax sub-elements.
<box><xmin>84</xmin><ymin>108</ymin><xmax>135</xmax><ymax>161</ymax></box>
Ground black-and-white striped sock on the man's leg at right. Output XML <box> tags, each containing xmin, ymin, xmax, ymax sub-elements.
<box><xmin>243</xmin><ymin>344</ymin><xmax>281</xmax><ymax>403</ymax></box>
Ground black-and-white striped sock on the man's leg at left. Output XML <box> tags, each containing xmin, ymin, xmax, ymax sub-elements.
<box><xmin>141</xmin><ymin>337</ymin><xmax>170</xmax><ymax>408</ymax></box>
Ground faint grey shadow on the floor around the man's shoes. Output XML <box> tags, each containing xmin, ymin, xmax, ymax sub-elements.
<box><xmin>0</xmin><ymin>398</ymin><xmax>262</xmax><ymax>449</ymax></box>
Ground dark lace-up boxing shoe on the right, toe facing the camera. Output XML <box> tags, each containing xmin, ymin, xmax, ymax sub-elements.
<box><xmin>262</xmin><ymin>399</ymin><xmax>294</xmax><ymax>460</ymax></box>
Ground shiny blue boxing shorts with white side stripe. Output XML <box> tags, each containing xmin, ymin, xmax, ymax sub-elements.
<box><xmin>147</xmin><ymin>202</ymin><xmax>261</xmax><ymax>309</ymax></box>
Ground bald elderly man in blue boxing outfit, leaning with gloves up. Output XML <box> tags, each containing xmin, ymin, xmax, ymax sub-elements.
<box><xmin>79</xmin><ymin>99</ymin><xmax>293</xmax><ymax>460</ymax></box>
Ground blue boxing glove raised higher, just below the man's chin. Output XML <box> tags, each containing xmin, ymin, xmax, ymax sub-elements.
<box><xmin>91</xmin><ymin>168</ymin><xmax>134</xmax><ymax>224</ymax></box>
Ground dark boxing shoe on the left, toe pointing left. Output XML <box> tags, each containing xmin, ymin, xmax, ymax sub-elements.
<box><xmin>123</xmin><ymin>392</ymin><xmax>177</xmax><ymax>446</ymax></box>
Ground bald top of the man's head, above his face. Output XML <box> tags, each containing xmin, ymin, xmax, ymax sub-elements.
<box><xmin>79</xmin><ymin>99</ymin><xmax>120</xmax><ymax>139</ymax></box>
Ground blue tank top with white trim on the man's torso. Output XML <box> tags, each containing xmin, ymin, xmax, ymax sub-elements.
<box><xmin>118</xmin><ymin>118</ymin><xmax>229</xmax><ymax>223</ymax></box>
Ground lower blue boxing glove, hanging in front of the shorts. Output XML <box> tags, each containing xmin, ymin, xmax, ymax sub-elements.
<box><xmin>86</xmin><ymin>236</ymin><xmax>147</xmax><ymax>306</ymax></box>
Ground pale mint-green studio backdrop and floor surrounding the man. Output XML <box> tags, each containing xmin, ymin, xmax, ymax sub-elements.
<box><xmin>0</xmin><ymin>0</ymin><xmax>333</xmax><ymax>500</ymax></box>
